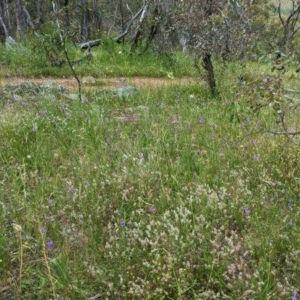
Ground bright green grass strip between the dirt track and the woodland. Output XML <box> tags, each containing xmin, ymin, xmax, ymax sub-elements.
<box><xmin>0</xmin><ymin>39</ymin><xmax>196</xmax><ymax>78</ymax></box>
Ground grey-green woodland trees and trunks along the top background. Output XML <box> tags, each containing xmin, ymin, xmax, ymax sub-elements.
<box><xmin>0</xmin><ymin>0</ymin><xmax>300</xmax><ymax>93</ymax></box>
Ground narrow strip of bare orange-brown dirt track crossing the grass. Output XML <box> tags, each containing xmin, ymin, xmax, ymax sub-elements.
<box><xmin>0</xmin><ymin>77</ymin><xmax>196</xmax><ymax>90</ymax></box>
